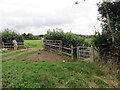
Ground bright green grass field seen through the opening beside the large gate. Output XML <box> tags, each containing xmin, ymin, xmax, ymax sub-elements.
<box><xmin>24</xmin><ymin>40</ymin><xmax>43</xmax><ymax>48</ymax></box>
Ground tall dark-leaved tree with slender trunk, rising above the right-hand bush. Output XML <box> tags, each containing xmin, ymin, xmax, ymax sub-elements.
<box><xmin>98</xmin><ymin>2</ymin><xmax>120</xmax><ymax>42</ymax></box>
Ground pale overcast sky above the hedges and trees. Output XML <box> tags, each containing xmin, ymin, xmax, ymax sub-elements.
<box><xmin>0</xmin><ymin>0</ymin><xmax>100</xmax><ymax>35</ymax></box>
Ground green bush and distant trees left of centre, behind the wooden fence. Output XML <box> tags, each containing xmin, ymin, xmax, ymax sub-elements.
<box><xmin>0</xmin><ymin>29</ymin><xmax>43</xmax><ymax>43</ymax></box>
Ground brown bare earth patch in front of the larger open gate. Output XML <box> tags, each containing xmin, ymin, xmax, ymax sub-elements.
<box><xmin>22</xmin><ymin>50</ymin><xmax>63</xmax><ymax>61</ymax></box>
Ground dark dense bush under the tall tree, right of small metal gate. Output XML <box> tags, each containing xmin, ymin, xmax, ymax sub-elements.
<box><xmin>94</xmin><ymin>32</ymin><xmax>120</xmax><ymax>57</ymax></box>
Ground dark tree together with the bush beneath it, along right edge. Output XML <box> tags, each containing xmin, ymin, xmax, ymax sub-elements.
<box><xmin>94</xmin><ymin>1</ymin><xmax>120</xmax><ymax>60</ymax></box>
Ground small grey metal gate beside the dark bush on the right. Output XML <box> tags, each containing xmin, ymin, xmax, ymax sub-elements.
<box><xmin>77</xmin><ymin>46</ymin><xmax>94</xmax><ymax>63</ymax></box>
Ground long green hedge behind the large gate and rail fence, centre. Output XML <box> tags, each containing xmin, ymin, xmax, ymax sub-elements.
<box><xmin>45</xmin><ymin>29</ymin><xmax>84</xmax><ymax>47</ymax></box>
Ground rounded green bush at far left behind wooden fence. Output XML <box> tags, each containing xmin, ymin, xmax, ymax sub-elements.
<box><xmin>0</xmin><ymin>29</ymin><xmax>23</xmax><ymax>43</ymax></box>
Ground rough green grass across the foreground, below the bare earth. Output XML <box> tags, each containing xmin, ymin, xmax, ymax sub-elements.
<box><xmin>2</xmin><ymin>57</ymin><xmax>117</xmax><ymax>88</ymax></box>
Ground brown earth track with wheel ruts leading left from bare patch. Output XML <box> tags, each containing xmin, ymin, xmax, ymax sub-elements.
<box><xmin>0</xmin><ymin>48</ymin><xmax>64</xmax><ymax>62</ymax></box>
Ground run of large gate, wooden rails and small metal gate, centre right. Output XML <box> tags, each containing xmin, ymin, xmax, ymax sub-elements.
<box><xmin>44</xmin><ymin>40</ymin><xmax>94</xmax><ymax>63</ymax></box>
